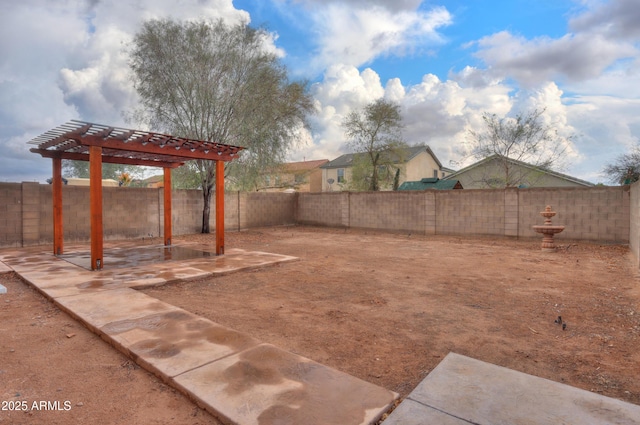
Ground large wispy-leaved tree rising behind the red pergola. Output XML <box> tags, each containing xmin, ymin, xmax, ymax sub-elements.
<box><xmin>130</xmin><ymin>19</ymin><xmax>312</xmax><ymax>233</ymax></box>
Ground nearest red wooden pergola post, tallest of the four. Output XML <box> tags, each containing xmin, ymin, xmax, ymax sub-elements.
<box><xmin>89</xmin><ymin>146</ymin><xmax>104</xmax><ymax>270</ymax></box>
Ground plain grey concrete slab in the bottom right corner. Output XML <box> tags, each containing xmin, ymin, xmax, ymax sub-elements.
<box><xmin>384</xmin><ymin>353</ymin><xmax>640</xmax><ymax>425</ymax></box>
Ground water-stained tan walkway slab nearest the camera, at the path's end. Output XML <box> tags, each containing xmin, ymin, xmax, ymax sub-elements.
<box><xmin>173</xmin><ymin>344</ymin><xmax>398</xmax><ymax>425</ymax></box>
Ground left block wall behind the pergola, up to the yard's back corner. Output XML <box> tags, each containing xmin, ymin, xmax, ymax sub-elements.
<box><xmin>0</xmin><ymin>183</ymin><xmax>297</xmax><ymax>247</ymax></box>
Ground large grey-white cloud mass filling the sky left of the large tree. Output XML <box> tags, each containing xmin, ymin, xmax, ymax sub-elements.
<box><xmin>0</xmin><ymin>0</ymin><xmax>250</xmax><ymax>181</ymax></box>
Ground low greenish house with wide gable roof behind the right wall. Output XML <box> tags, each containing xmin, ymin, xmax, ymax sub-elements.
<box><xmin>446</xmin><ymin>155</ymin><xmax>594</xmax><ymax>189</ymax></box>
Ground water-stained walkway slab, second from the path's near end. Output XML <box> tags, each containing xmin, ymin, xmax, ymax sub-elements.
<box><xmin>100</xmin><ymin>310</ymin><xmax>260</xmax><ymax>380</ymax></box>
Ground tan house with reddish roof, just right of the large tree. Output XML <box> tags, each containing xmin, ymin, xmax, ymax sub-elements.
<box><xmin>263</xmin><ymin>159</ymin><xmax>329</xmax><ymax>192</ymax></box>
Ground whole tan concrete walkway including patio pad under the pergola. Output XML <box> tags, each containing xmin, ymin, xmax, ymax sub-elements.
<box><xmin>0</xmin><ymin>244</ymin><xmax>398</xmax><ymax>425</ymax></box>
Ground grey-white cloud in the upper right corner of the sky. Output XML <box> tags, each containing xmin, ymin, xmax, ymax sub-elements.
<box><xmin>467</xmin><ymin>0</ymin><xmax>640</xmax><ymax>87</ymax></box>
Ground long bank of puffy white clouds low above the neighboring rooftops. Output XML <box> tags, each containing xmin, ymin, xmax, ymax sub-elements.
<box><xmin>291</xmin><ymin>65</ymin><xmax>616</xmax><ymax>182</ymax></box>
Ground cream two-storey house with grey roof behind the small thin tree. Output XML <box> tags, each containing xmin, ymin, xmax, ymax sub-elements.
<box><xmin>320</xmin><ymin>146</ymin><xmax>453</xmax><ymax>192</ymax></box>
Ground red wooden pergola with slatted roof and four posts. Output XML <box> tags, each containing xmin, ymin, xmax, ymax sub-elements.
<box><xmin>29</xmin><ymin>120</ymin><xmax>243</xmax><ymax>270</ymax></box>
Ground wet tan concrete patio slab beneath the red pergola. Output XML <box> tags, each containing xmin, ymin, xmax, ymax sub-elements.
<box><xmin>0</xmin><ymin>242</ymin><xmax>298</xmax><ymax>298</ymax></box>
